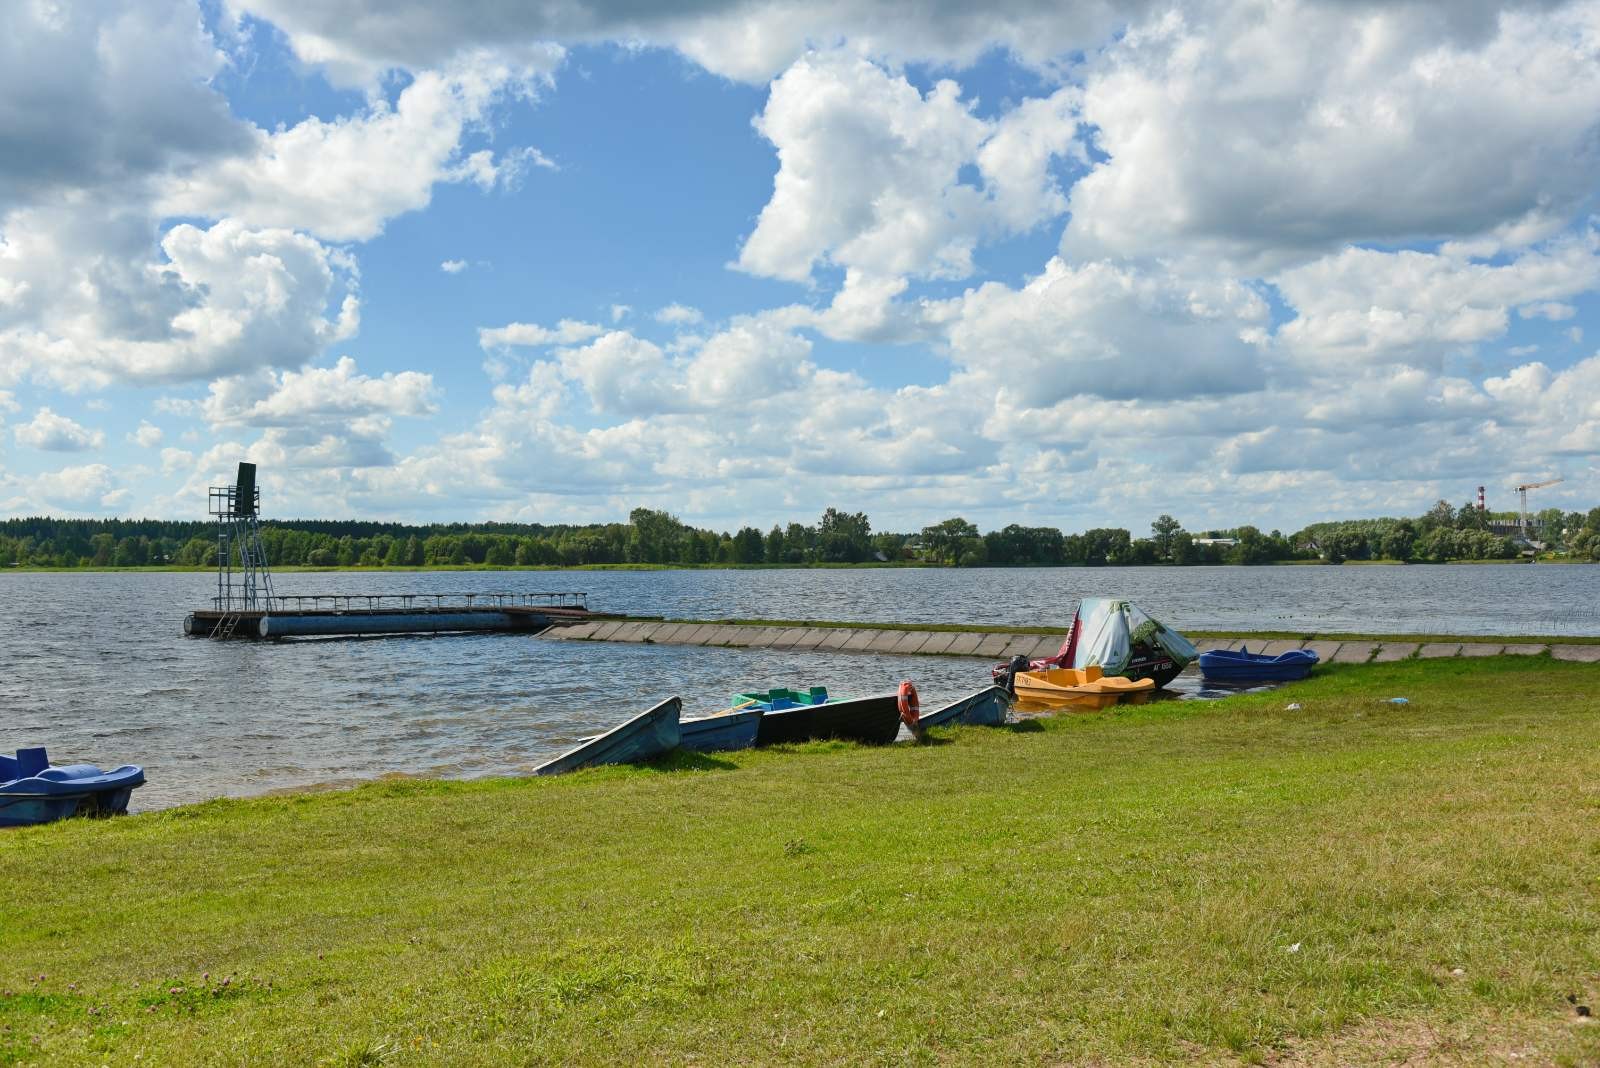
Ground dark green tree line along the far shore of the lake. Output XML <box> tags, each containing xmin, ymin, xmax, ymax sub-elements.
<box><xmin>0</xmin><ymin>500</ymin><xmax>1600</xmax><ymax>568</ymax></box>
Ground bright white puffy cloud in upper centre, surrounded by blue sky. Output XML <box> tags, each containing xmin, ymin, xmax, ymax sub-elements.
<box><xmin>738</xmin><ymin>51</ymin><xmax>1077</xmax><ymax>281</ymax></box>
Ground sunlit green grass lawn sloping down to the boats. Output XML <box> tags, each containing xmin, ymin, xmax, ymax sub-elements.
<box><xmin>0</xmin><ymin>657</ymin><xmax>1600</xmax><ymax>1065</ymax></box>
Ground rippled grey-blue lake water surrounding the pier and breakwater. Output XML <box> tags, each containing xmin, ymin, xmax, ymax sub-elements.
<box><xmin>0</xmin><ymin>564</ymin><xmax>1600</xmax><ymax>809</ymax></box>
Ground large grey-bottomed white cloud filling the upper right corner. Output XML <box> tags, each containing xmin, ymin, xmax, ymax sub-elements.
<box><xmin>1062</xmin><ymin>0</ymin><xmax>1600</xmax><ymax>269</ymax></box>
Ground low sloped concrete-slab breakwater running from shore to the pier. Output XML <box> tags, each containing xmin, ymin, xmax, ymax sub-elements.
<box><xmin>541</xmin><ymin>620</ymin><xmax>1600</xmax><ymax>664</ymax></box>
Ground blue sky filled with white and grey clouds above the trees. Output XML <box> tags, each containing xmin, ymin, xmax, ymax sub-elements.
<box><xmin>0</xmin><ymin>0</ymin><xmax>1600</xmax><ymax>529</ymax></box>
